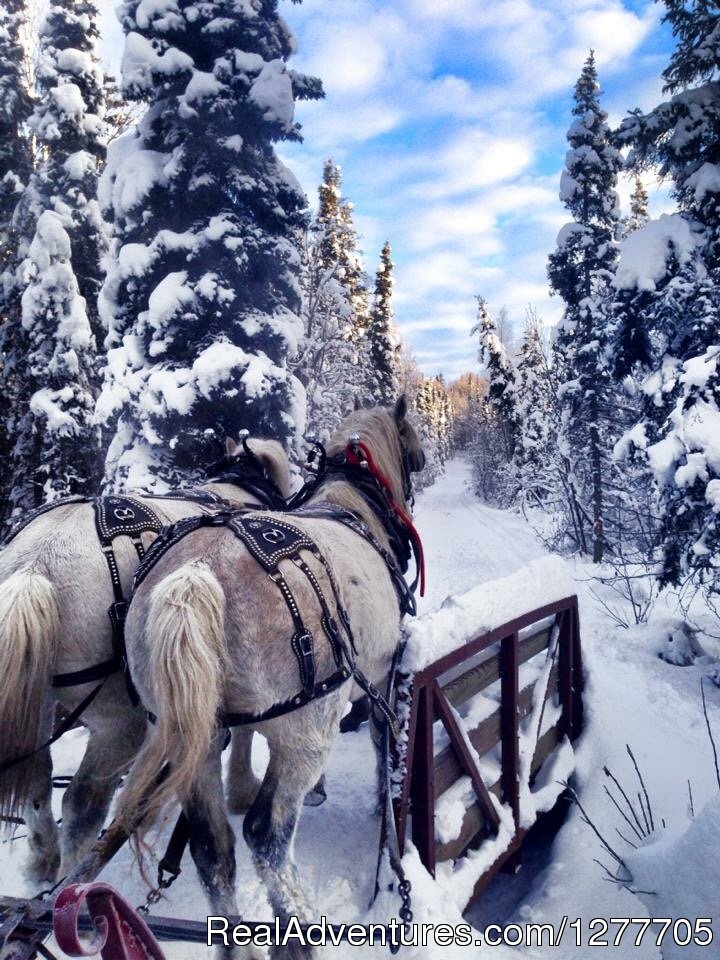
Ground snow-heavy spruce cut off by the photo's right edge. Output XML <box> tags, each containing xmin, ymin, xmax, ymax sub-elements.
<box><xmin>616</xmin><ymin>0</ymin><xmax>720</xmax><ymax>595</ymax></box>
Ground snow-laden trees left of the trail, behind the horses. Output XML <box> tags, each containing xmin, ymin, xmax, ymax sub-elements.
<box><xmin>0</xmin><ymin>0</ymin><xmax>451</xmax><ymax>520</ymax></box>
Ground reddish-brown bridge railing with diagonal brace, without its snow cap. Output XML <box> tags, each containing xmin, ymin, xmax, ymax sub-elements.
<box><xmin>394</xmin><ymin>596</ymin><xmax>583</xmax><ymax>902</ymax></box>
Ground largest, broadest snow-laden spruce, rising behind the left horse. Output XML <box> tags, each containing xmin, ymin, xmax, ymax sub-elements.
<box><xmin>98</xmin><ymin>0</ymin><xmax>322</xmax><ymax>486</ymax></box>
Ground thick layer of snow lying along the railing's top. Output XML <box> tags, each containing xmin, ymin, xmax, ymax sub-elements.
<box><xmin>403</xmin><ymin>556</ymin><xmax>575</xmax><ymax>673</ymax></box>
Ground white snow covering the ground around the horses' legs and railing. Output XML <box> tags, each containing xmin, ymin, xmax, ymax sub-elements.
<box><xmin>0</xmin><ymin>460</ymin><xmax>720</xmax><ymax>960</ymax></box>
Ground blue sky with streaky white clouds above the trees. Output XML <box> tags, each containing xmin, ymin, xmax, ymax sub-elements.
<box><xmin>101</xmin><ymin>0</ymin><xmax>672</xmax><ymax>379</ymax></box>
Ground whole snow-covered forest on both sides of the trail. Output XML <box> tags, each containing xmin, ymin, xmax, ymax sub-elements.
<box><xmin>0</xmin><ymin>0</ymin><xmax>720</xmax><ymax>652</ymax></box>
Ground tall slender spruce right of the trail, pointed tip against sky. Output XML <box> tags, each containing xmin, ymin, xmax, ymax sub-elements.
<box><xmin>548</xmin><ymin>53</ymin><xmax>621</xmax><ymax>562</ymax></box>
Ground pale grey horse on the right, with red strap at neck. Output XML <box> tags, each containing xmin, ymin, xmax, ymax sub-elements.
<box><xmin>116</xmin><ymin>398</ymin><xmax>424</xmax><ymax>956</ymax></box>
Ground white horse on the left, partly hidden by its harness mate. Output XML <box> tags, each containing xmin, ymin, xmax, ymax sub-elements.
<box><xmin>0</xmin><ymin>439</ymin><xmax>290</xmax><ymax>883</ymax></box>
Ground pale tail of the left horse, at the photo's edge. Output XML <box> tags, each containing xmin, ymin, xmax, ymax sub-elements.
<box><xmin>0</xmin><ymin>566</ymin><xmax>60</xmax><ymax>822</ymax></box>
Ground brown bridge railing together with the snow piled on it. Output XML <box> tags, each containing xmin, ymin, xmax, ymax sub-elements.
<box><xmin>394</xmin><ymin>557</ymin><xmax>582</xmax><ymax>903</ymax></box>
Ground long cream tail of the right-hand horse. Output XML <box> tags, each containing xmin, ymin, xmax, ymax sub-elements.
<box><xmin>116</xmin><ymin>561</ymin><xmax>225</xmax><ymax>838</ymax></box>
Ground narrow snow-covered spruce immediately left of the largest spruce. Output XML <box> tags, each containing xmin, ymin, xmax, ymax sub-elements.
<box><xmin>2</xmin><ymin>0</ymin><xmax>105</xmax><ymax>509</ymax></box>
